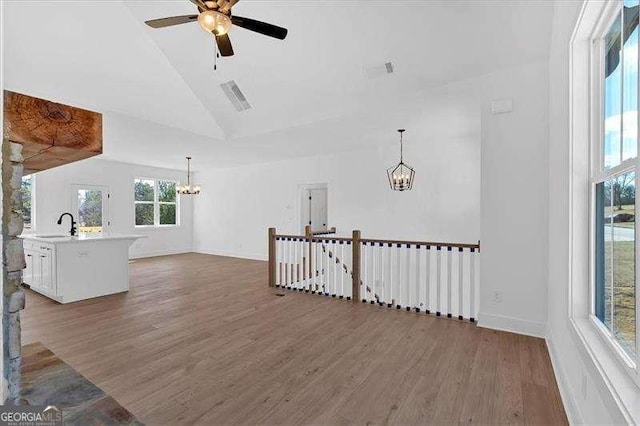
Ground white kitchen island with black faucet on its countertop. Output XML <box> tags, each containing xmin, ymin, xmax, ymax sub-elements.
<box><xmin>21</xmin><ymin>234</ymin><xmax>144</xmax><ymax>303</ymax></box>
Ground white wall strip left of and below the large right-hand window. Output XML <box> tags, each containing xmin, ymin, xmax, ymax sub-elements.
<box><xmin>547</xmin><ymin>1</ymin><xmax>626</xmax><ymax>424</ymax></box>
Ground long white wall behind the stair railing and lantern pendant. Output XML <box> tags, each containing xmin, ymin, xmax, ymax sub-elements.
<box><xmin>194</xmin><ymin>88</ymin><xmax>480</xmax><ymax>259</ymax></box>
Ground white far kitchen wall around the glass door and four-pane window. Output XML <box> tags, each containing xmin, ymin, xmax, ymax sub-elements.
<box><xmin>35</xmin><ymin>158</ymin><xmax>193</xmax><ymax>258</ymax></box>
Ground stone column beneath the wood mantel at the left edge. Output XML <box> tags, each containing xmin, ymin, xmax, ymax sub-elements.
<box><xmin>1</xmin><ymin>139</ymin><xmax>26</xmax><ymax>405</ymax></box>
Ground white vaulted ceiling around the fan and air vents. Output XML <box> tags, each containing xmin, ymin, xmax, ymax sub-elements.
<box><xmin>3</xmin><ymin>0</ymin><xmax>552</xmax><ymax>167</ymax></box>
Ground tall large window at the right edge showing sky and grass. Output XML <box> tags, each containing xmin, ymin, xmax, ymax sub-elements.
<box><xmin>591</xmin><ymin>0</ymin><xmax>639</xmax><ymax>368</ymax></box>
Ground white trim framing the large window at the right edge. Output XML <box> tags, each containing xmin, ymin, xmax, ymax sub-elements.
<box><xmin>568</xmin><ymin>0</ymin><xmax>640</xmax><ymax>423</ymax></box>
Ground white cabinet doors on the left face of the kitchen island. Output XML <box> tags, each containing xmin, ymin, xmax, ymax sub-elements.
<box><xmin>23</xmin><ymin>241</ymin><xmax>57</xmax><ymax>298</ymax></box>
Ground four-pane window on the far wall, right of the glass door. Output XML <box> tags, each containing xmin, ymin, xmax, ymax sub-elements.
<box><xmin>134</xmin><ymin>178</ymin><xmax>179</xmax><ymax>226</ymax></box>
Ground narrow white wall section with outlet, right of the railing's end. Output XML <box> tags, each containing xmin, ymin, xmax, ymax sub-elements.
<box><xmin>478</xmin><ymin>62</ymin><xmax>548</xmax><ymax>336</ymax></box>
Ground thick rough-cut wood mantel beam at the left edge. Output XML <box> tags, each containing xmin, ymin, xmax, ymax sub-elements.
<box><xmin>3</xmin><ymin>90</ymin><xmax>102</xmax><ymax>175</ymax></box>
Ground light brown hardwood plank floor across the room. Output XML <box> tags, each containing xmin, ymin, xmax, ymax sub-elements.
<box><xmin>22</xmin><ymin>254</ymin><xmax>567</xmax><ymax>425</ymax></box>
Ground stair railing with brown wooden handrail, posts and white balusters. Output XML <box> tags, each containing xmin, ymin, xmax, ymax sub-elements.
<box><xmin>268</xmin><ymin>226</ymin><xmax>480</xmax><ymax>316</ymax></box>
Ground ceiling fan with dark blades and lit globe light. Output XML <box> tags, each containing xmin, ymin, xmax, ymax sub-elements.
<box><xmin>145</xmin><ymin>0</ymin><xmax>287</xmax><ymax>56</ymax></box>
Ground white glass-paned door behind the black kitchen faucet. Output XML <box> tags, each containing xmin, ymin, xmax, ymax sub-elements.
<box><xmin>71</xmin><ymin>185</ymin><xmax>111</xmax><ymax>233</ymax></box>
